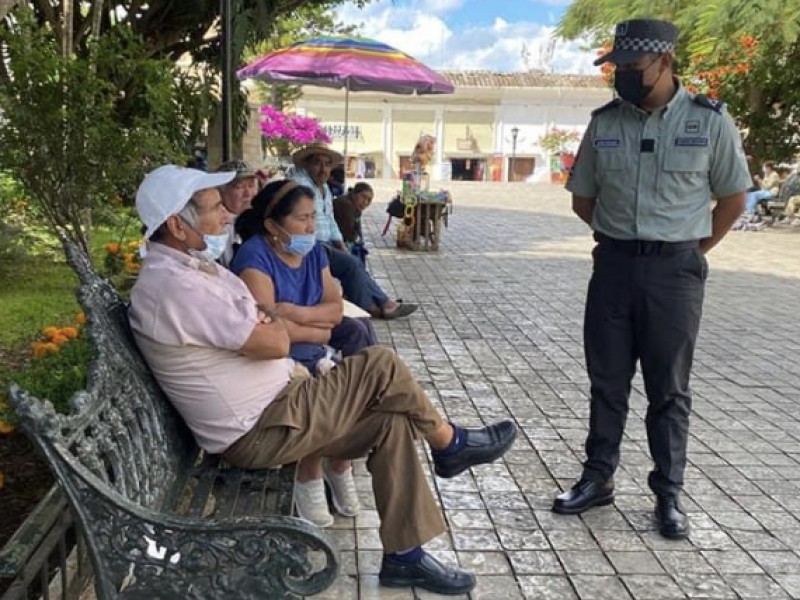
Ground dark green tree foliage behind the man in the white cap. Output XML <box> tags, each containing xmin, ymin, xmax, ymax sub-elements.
<box><xmin>0</xmin><ymin>0</ymin><xmax>368</xmax><ymax>255</ymax></box>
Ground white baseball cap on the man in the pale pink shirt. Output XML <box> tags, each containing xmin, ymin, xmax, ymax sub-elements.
<box><xmin>136</xmin><ymin>165</ymin><xmax>236</xmax><ymax>240</ymax></box>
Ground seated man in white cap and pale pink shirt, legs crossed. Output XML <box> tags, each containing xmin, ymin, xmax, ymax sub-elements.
<box><xmin>130</xmin><ymin>165</ymin><xmax>516</xmax><ymax>594</ymax></box>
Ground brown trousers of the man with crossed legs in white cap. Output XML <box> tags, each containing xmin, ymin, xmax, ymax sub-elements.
<box><xmin>225</xmin><ymin>347</ymin><xmax>446</xmax><ymax>552</ymax></box>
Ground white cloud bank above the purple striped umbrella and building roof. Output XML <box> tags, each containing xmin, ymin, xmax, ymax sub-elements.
<box><xmin>338</xmin><ymin>0</ymin><xmax>600</xmax><ymax>74</ymax></box>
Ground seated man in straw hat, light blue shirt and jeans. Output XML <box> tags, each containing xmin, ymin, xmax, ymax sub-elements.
<box><xmin>292</xmin><ymin>143</ymin><xmax>417</xmax><ymax>319</ymax></box>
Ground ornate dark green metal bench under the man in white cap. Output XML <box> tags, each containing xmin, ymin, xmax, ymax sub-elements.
<box><xmin>3</xmin><ymin>244</ymin><xmax>338</xmax><ymax>600</ymax></box>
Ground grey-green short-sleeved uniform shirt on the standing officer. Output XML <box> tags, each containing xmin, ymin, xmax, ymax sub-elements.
<box><xmin>567</xmin><ymin>84</ymin><xmax>751</xmax><ymax>242</ymax></box>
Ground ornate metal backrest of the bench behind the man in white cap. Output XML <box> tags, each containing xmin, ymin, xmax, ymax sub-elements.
<box><xmin>11</xmin><ymin>242</ymin><xmax>198</xmax><ymax>508</ymax></box>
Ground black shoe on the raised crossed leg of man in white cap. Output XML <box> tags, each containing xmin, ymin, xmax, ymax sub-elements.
<box><xmin>433</xmin><ymin>421</ymin><xmax>517</xmax><ymax>479</ymax></box>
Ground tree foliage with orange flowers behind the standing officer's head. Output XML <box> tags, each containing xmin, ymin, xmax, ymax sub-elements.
<box><xmin>558</xmin><ymin>0</ymin><xmax>800</xmax><ymax>160</ymax></box>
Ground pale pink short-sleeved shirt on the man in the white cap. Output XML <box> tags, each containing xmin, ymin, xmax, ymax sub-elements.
<box><xmin>129</xmin><ymin>243</ymin><xmax>294</xmax><ymax>454</ymax></box>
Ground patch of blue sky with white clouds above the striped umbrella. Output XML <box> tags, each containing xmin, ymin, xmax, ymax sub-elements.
<box><xmin>338</xmin><ymin>0</ymin><xmax>599</xmax><ymax>74</ymax></box>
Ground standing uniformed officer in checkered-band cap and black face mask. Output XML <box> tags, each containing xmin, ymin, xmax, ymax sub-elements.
<box><xmin>553</xmin><ymin>19</ymin><xmax>750</xmax><ymax>538</ymax></box>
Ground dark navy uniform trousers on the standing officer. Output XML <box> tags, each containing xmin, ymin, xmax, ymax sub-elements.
<box><xmin>583</xmin><ymin>234</ymin><xmax>708</xmax><ymax>493</ymax></box>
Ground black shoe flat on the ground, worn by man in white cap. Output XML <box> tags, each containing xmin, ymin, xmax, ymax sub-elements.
<box><xmin>378</xmin><ymin>552</ymin><xmax>475</xmax><ymax>596</ymax></box>
